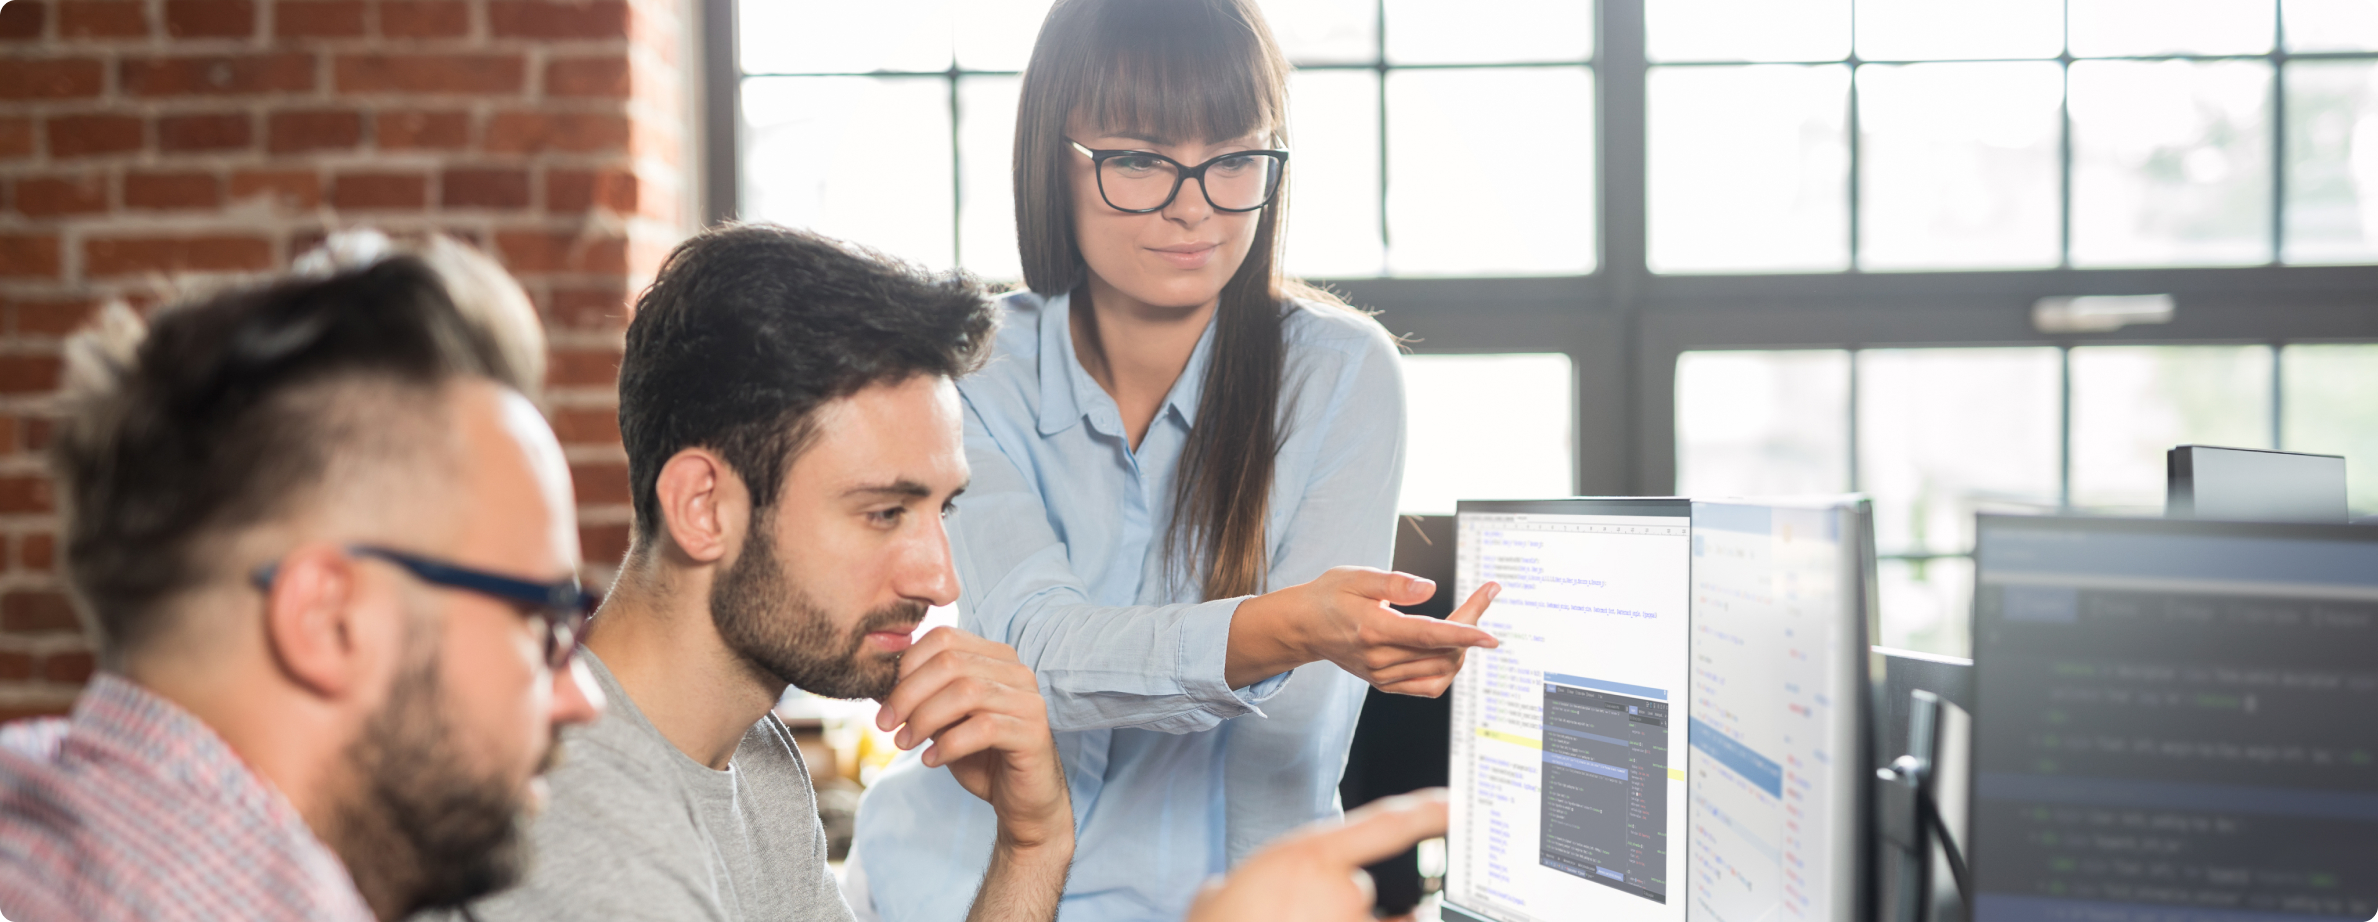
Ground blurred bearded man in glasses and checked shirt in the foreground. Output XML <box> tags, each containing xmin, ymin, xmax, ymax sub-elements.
<box><xmin>0</xmin><ymin>247</ymin><xmax>602</xmax><ymax>922</ymax></box>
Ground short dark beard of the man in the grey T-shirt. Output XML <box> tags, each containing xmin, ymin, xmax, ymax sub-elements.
<box><xmin>711</xmin><ymin>518</ymin><xmax>925</xmax><ymax>701</ymax></box>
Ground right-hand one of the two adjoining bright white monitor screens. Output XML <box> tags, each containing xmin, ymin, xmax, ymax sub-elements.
<box><xmin>1686</xmin><ymin>504</ymin><xmax>1874</xmax><ymax>922</ymax></box>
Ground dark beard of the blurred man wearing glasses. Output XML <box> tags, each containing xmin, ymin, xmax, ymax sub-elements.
<box><xmin>338</xmin><ymin>625</ymin><xmax>561</xmax><ymax>917</ymax></box>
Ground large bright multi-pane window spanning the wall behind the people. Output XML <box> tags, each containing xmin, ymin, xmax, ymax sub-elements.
<box><xmin>704</xmin><ymin>0</ymin><xmax>2378</xmax><ymax>651</ymax></box>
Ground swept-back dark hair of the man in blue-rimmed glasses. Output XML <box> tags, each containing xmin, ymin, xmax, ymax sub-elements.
<box><xmin>50</xmin><ymin>257</ymin><xmax>521</xmax><ymax>661</ymax></box>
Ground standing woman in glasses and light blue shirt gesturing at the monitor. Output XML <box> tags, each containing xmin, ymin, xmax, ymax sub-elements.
<box><xmin>849</xmin><ymin>0</ymin><xmax>1496</xmax><ymax>922</ymax></box>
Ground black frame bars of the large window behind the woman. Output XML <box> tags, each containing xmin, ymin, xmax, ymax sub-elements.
<box><xmin>702</xmin><ymin>0</ymin><xmax>2378</xmax><ymax>503</ymax></box>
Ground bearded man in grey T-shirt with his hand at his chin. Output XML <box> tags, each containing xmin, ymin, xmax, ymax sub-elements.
<box><xmin>442</xmin><ymin>226</ymin><xmax>1072</xmax><ymax>922</ymax></box>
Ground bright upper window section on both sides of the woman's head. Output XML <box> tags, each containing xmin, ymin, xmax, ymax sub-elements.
<box><xmin>737</xmin><ymin>0</ymin><xmax>1596</xmax><ymax>278</ymax></box>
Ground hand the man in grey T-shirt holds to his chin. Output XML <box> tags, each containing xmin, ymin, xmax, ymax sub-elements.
<box><xmin>875</xmin><ymin>627</ymin><xmax>1072</xmax><ymax>855</ymax></box>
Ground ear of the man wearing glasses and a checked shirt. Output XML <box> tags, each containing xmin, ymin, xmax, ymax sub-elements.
<box><xmin>264</xmin><ymin>544</ymin><xmax>364</xmax><ymax>699</ymax></box>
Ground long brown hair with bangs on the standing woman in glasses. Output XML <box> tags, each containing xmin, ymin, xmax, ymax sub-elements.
<box><xmin>1015</xmin><ymin>0</ymin><xmax>1310</xmax><ymax>599</ymax></box>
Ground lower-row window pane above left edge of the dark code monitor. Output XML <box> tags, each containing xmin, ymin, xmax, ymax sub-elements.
<box><xmin>1857</xmin><ymin>347</ymin><xmax>2062</xmax><ymax>554</ymax></box>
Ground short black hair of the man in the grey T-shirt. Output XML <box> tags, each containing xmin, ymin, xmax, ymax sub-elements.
<box><xmin>618</xmin><ymin>223</ymin><xmax>994</xmax><ymax>547</ymax></box>
